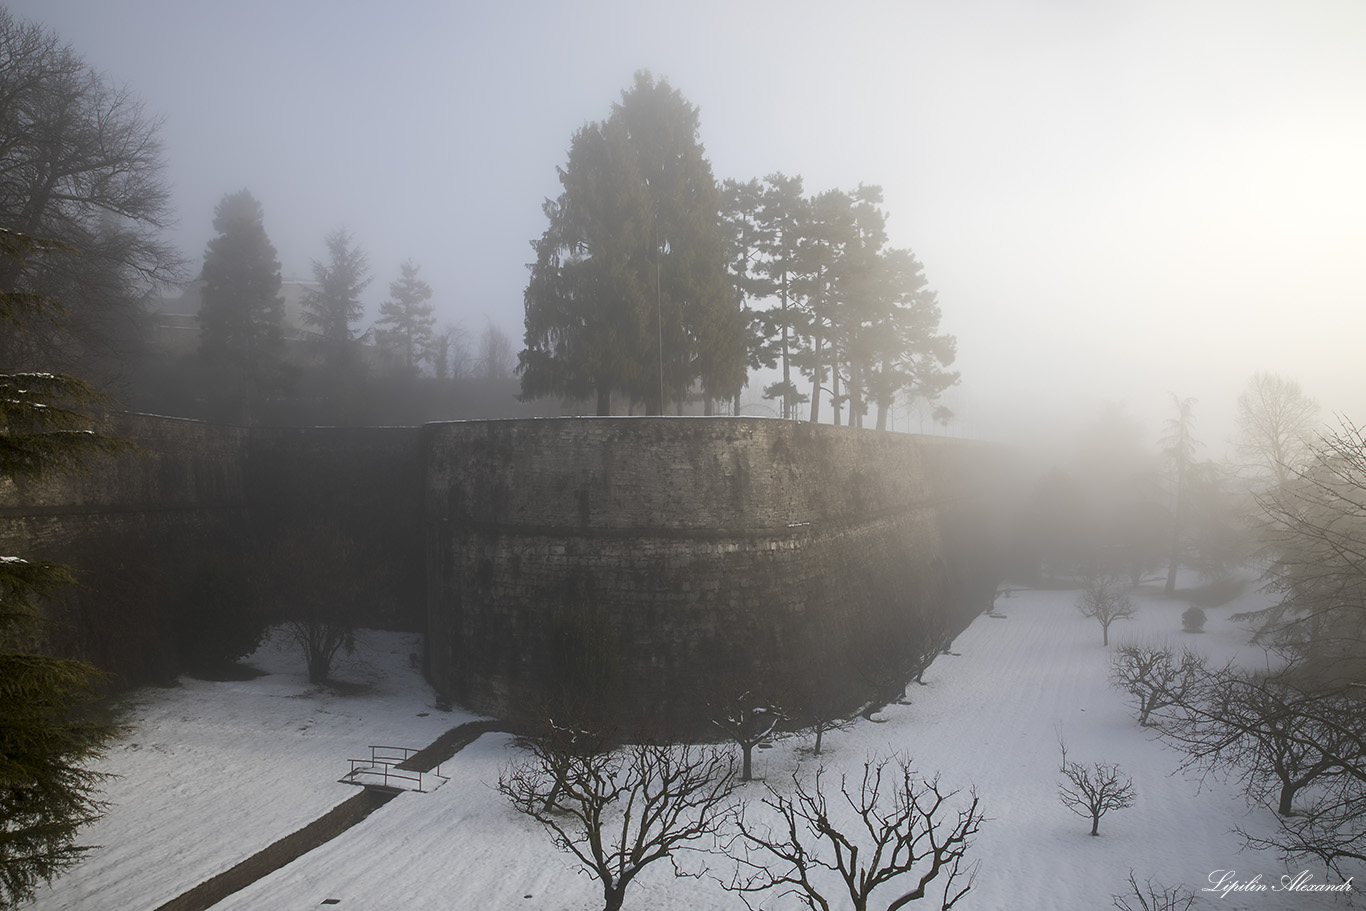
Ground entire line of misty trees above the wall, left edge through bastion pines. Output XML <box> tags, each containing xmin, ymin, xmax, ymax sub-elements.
<box><xmin>0</xmin><ymin>6</ymin><xmax>958</xmax><ymax>428</ymax></box>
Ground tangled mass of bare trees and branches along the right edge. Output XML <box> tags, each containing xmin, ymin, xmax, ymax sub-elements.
<box><xmin>1164</xmin><ymin>422</ymin><xmax>1366</xmax><ymax>871</ymax></box>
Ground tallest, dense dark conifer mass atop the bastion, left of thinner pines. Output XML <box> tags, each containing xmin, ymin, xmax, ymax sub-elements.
<box><xmin>518</xmin><ymin>72</ymin><xmax>746</xmax><ymax>414</ymax></box>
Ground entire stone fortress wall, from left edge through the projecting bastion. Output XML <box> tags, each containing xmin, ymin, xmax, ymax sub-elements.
<box><xmin>0</xmin><ymin>415</ymin><xmax>1000</xmax><ymax>724</ymax></box>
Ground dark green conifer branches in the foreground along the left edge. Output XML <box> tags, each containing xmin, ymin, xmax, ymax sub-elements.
<box><xmin>0</xmin><ymin>229</ymin><xmax>124</xmax><ymax>906</ymax></box>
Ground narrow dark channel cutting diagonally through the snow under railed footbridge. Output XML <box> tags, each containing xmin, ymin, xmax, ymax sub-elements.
<box><xmin>156</xmin><ymin>721</ymin><xmax>501</xmax><ymax>911</ymax></box>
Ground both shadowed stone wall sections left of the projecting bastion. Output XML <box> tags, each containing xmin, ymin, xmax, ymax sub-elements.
<box><xmin>0</xmin><ymin>414</ymin><xmax>426</xmax><ymax>687</ymax></box>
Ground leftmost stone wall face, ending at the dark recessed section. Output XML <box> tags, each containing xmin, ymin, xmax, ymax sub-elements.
<box><xmin>0</xmin><ymin>415</ymin><xmax>250</xmax><ymax>687</ymax></box>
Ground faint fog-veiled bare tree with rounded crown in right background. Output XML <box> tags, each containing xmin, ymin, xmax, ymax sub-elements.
<box><xmin>1238</xmin><ymin>372</ymin><xmax>1318</xmax><ymax>486</ymax></box>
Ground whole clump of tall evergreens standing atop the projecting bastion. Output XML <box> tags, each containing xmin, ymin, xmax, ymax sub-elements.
<box><xmin>518</xmin><ymin>72</ymin><xmax>958</xmax><ymax>429</ymax></box>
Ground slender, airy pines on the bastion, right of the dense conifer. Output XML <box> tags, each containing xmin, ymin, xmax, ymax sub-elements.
<box><xmin>724</xmin><ymin>181</ymin><xmax>958</xmax><ymax>430</ymax></box>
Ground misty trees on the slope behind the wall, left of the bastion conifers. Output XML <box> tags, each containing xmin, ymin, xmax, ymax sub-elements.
<box><xmin>0</xmin><ymin>3</ymin><xmax>516</xmax><ymax>423</ymax></box>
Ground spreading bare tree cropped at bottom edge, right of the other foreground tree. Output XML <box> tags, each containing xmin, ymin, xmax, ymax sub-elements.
<box><xmin>723</xmin><ymin>757</ymin><xmax>982</xmax><ymax>911</ymax></box>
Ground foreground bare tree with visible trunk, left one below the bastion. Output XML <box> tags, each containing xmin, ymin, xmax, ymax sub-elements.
<box><xmin>499</xmin><ymin>742</ymin><xmax>735</xmax><ymax>911</ymax></box>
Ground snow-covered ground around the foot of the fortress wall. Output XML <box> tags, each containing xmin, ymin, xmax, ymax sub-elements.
<box><xmin>18</xmin><ymin>589</ymin><xmax>1366</xmax><ymax>911</ymax></box>
